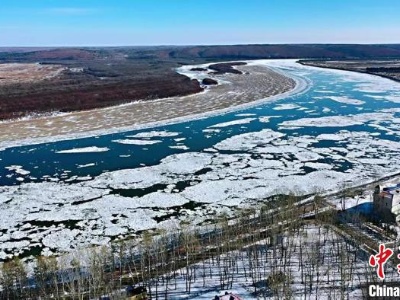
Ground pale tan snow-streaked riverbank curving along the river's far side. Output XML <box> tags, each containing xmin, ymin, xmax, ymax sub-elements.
<box><xmin>0</xmin><ymin>61</ymin><xmax>296</xmax><ymax>148</ymax></box>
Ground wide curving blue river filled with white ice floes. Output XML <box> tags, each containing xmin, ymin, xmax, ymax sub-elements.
<box><xmin>0</xmin><ymin>61</ymin><xmax>400</xmax><ymax>259</ymax></box>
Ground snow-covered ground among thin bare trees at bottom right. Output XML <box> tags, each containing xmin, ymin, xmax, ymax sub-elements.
<box><xmin>144</xmin><ymin>225</ymin><xmax>398</xmax><ymax>300</ymax></box>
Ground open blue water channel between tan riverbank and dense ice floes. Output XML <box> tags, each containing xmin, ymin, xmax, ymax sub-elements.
<box><xmin>0</xmin><ymin>63</ymin><xmax>400</xmax><ymax>185</ymax></box>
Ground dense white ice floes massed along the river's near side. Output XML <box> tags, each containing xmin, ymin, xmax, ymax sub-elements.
<box><xmin>4</xmin><ymin>121</ymin><xmax>400</xmax><ymax>255</ymax></box>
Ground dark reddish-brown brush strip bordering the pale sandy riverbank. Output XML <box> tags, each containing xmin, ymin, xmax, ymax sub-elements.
<box><xmin>0</xmin><ymin>73</ymin><xmax>202</xmax><ymax>119</ymax></box>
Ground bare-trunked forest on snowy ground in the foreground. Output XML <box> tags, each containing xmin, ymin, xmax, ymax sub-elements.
<box><xmin>0</xmin><ymin>195</ymin><xmax>398</xmax><ymax>299</ymax></box>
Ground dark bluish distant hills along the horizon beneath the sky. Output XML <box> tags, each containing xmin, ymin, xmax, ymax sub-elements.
<box><xmin>0</xmin><ymin>44</ymin><xmax>400</xmax><ymax>62</ymax></box>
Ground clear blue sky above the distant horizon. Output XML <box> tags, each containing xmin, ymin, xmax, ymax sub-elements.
<box><xmin>0</xmin><ymin>0</ymin><xmax>400</xmax><ymax>46</ymax></box>
